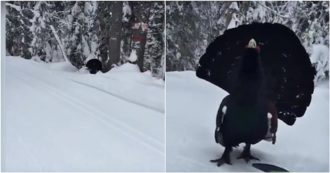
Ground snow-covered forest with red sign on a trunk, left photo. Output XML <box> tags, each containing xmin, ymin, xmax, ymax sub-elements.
<box><xmin>5</xmin><ymin>1</ymin><xmax>165</xmax><ymax>79</ymax></box>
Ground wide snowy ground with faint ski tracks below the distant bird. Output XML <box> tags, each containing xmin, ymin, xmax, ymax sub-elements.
<box><xmin>2</xmin><ymin>57</ymin><xmax>165</xmax><ymax>172</ymax></box>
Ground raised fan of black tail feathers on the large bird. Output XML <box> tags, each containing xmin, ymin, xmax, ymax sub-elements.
<box><xmin>196</xmin><ymin>23</ymin><xmax>315</xmax><ymax>125</ymax></box>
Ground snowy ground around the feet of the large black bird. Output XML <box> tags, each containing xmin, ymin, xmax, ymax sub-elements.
<box><xmin>166</xmin><ymin>72</ymin><xmax>329</xmax><ymax>172</ymax></box>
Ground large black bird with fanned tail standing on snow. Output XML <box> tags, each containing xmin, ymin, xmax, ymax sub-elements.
<box><xmin>196</xmin><ymin>23</ymin><xmax>315</xmax><ymax>166</ymax></box>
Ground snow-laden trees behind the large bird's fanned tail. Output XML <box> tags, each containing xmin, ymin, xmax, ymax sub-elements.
<box><xmin>166</xmin><ymin>1</ymin><xmax>329</xmax><ymax>81</ymax></box>
